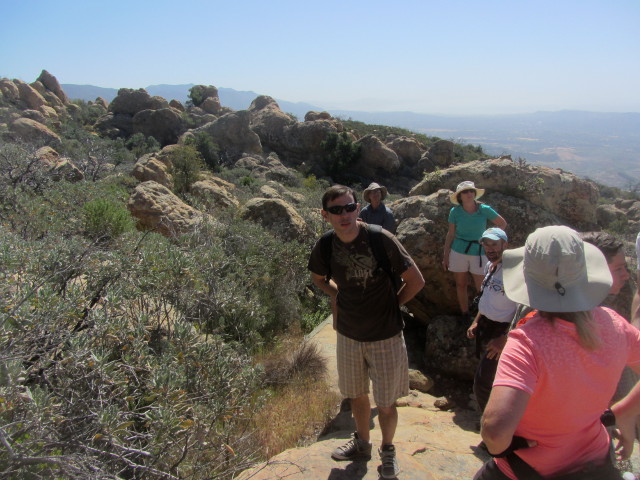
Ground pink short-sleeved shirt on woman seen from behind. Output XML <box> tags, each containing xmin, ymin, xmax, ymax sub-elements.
<box><xmin>493</xmin><ymin>307</ymin><xmax>640</xmax><ymax>479</ymax></box>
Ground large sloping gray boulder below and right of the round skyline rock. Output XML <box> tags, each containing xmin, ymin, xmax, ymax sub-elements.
<box><xmin>192</xmin><ymin>110</ymin><xmax>262</xmax><ymax>160</ymax></box>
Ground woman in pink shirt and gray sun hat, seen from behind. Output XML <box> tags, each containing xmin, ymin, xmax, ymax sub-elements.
<box><xmin>474</xmin><ymin>226</ymin><xmax>640</xmax><ymax>480</ymax></box>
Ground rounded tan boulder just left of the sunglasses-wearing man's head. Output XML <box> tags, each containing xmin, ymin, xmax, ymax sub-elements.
<box><xmin>240</xmin><ymin>198</ymin><xmax>310</xmax><ymax>241</ymax></box>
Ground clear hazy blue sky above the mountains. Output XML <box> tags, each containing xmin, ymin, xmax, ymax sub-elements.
<box><xmin>0</xmin><ymin>0</ymin><xmax>640</xmax><ymax>114</ymax></box>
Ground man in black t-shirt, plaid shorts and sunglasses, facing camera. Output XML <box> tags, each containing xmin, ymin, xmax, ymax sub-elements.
<box><xmin>309</xmin><ymin>185</ymin><xmax>424</xmax><ymax>478</ymax></box>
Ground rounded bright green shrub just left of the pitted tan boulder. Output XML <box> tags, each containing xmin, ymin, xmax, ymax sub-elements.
<box><xmin>84</xmin><ymin>199</ymin><xmax>134</xmax><ymax>241</ymax></box>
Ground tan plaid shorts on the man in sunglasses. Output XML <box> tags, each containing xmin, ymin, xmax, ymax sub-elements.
<box><xmin>337</xmin><ymin>332</ymin><xmax>409</xmax><ymax>407</ymax></box>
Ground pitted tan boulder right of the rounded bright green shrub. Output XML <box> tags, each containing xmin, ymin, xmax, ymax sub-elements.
<box><xmin>127</xmin><ymin>181</ymin><xmax>204</xmax><ymax>237</ymax></box>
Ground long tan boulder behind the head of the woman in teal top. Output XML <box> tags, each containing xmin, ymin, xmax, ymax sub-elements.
<box><xmin>409</xmin><ymin>157</ymin><xmax>598</xmax><ymax>230</ymax></box>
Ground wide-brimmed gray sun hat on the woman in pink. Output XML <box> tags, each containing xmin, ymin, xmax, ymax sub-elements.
<box><xmin>502</xmin><ymin>226</ymin><xmax>613</xmax><ymax>312</ymax></box>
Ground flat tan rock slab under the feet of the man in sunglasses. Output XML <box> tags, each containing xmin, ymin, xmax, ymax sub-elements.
<box><xmin>238</xmin><ymin>392</ymin><xmax>488</xmax><ymax>480</ymax></box>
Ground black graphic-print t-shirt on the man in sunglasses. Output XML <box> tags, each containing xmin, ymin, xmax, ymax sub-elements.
<box><xmin>308</xmin><ymin>223</ymin><xmax>413</xmax><ymax>342</ymax></box>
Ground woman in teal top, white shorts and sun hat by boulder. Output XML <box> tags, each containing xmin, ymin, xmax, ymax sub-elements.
<box><xmin>442</xmin><ymin>181</ymin><xmax>507</xmax><ymax>320</ymax></box>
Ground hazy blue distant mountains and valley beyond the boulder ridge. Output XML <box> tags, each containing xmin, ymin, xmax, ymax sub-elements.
<box><xmin>62</xmin><ymin>84</ymin><xmax>640</xmax><ymax>188</ymax></box>
